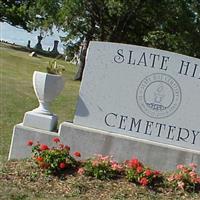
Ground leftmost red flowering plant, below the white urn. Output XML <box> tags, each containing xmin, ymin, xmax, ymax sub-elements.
<box><xmin>27</xmin><ymin>137</ymin><xmax>78</xmax><ymax>174</ymax></box>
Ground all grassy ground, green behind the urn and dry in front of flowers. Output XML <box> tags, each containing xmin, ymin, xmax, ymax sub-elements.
<box><xmin>0</xmin><ymin>44</ymin><xmax>200</xmax><ymax>200</ymax></box>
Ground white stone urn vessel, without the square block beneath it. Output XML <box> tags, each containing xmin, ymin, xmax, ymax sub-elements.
<box><xmin>33</xmin><ymin>71</ymin><xmax>64</xmax><ymax>115</ymax></box>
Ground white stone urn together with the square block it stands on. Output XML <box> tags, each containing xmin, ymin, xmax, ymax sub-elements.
<box><xmin>23</xmin><ymin>71</ymin><xmax>64</xmax><ymax>131</ymax></box>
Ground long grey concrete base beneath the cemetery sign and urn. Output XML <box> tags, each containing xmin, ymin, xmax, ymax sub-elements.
<box><xmin>9</xmin><ymin>122</ymin><xmax>200</xmax><ymax>172</ymax></box>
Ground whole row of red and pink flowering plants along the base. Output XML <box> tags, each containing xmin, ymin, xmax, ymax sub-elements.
<box><xmin>27</xmin><ymin>137</ymin><xmax>200</xmax><ymax>192</ymax></box>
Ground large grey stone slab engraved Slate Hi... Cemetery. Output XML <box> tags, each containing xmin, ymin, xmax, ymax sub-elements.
<box><xmin>74</xmin><ymin>42</ymin><xmax>200</xmax><ymax>151</ymax></box>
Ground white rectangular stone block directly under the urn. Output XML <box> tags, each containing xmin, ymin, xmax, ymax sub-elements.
<box><xmin>23</xmin><ymin>111</ymin><xmax>58</xmax><ymax>131</ymax></box>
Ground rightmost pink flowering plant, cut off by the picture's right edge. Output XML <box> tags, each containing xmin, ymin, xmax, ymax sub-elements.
<box><xmin>167</xmin><ymin>163</ymin><xmax>200</xmax><ymax>191</ymax></box>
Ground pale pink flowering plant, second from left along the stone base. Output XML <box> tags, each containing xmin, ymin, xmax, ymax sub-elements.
<box><xmin>78</xmin><ymin>155</ymin><xmax>123</xmax><ymax>180</ymax></box>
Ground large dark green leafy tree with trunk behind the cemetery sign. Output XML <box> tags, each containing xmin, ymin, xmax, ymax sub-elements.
<box><xmin>0</xmin><ymin>0</ymin><xmax>200</xmax><ymax>80</ymax></box>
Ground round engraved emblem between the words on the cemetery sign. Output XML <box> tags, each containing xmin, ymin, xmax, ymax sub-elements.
<box><xmin>136</xmin><ymin>73</ymin><xmax>181</xmax><ymax>118</ymax></box>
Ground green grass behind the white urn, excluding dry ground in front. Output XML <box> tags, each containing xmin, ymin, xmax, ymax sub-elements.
<box><xmin>0</xmin><ymin>45</ymin><xmax>80</xmax><ymax>161</ymax></box>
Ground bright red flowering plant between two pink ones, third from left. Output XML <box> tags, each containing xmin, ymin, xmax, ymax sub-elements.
<box><xmin>125</xmin><ymin>158</ymin><xmax>163</xmax><ymax>186</ymax></box>
